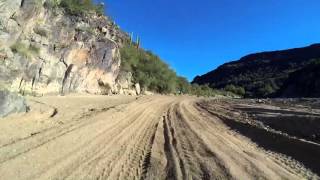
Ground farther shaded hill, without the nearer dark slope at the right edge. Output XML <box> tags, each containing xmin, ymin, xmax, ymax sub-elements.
<box><xmin>193</xmin><ymin>44</ymin><xmax>320</xmax><ymax>97</ymax></box>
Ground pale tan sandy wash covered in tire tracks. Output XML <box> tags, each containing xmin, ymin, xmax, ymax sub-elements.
<box><xmin>0</xmin><ymin>96</ymin><xmax>320</xmax><ymax>180</ymax></box>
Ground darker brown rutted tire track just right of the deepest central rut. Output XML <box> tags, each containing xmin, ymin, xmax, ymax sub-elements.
<box><xmin>166</xmin><ymin>103</ymin><xmax>230</xmax><ymax>179</ymax></box>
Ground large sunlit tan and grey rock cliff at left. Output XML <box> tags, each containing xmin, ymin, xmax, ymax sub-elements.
<box><xmin>0</xmin><ymin>0</ymin><xmax>128</xmax><ymax>95</ymax></box>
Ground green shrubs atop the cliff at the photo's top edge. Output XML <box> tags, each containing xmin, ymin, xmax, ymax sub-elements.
<box><xmin>59</xmin><ymin>0</ymin><xmax>104</xmax><ymax>15</ymax></box>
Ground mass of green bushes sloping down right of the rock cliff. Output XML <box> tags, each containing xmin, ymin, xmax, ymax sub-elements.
<box><xmin>121</xmin><ymin>43</ymin><xmax>226</xmax><ymax>96</ymax></box>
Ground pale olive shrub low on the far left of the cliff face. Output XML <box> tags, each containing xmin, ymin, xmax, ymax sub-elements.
<box><xmin>11</xmin><ymin>42</ymin><xmax>40</xmax><ymax>59</ymax></box>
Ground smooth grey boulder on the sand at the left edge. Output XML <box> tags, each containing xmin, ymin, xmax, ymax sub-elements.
<box><xmin>0</xmin><ymin>90</ymin><xmax>27</xmax><ymax>118</ymax></box>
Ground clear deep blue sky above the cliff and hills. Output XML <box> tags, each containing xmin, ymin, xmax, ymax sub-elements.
<box><xmin>100</xmin><ymin>0</ymin><xmax>320</xmax><ymax>80</ymax></box>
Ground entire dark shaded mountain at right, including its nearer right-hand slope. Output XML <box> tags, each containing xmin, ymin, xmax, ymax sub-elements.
<box><xmin>192</xmin><ymin>44</ymin><xmax>320</xmax><ymax>97</ymax></box>
